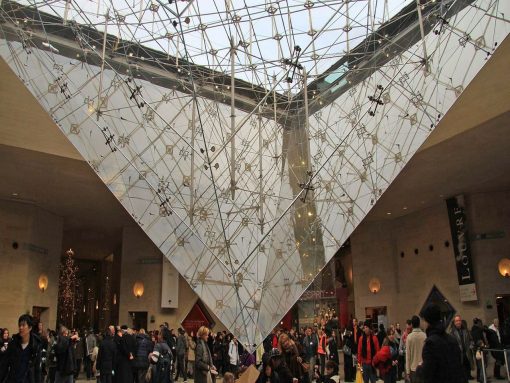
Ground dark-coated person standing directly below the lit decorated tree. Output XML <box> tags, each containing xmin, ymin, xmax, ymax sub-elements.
<box><xmin>55</xmin><ymin>326</ymin><xmax>78</xmax><ymax>383</ymax></box>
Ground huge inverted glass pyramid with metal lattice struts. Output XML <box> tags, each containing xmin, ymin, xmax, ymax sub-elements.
<box><xmin>0</xmin><ymin>0</ymin><xmax>510</xmax><ymax>345</ymax></box>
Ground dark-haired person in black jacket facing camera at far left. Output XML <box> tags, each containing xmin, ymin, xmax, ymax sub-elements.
<box><xmin>0</xmin><ymin>314</ymin><xmax>42</xmax><ymax>383</ymax></box>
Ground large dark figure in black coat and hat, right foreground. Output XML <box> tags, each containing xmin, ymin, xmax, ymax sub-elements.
<box><xmin>418</xmin><ymin>304</ymin><xmax>468</xmax><ymax>383</ymax></box>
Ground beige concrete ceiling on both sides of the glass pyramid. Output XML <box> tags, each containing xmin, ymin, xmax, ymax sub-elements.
<box><xmin>0</xmin><ymin>38</ymin><xmax>510</xmax><ymax>255</ymax></box>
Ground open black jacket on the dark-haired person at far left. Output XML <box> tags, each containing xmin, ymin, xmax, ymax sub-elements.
<box><xmin>0</xmin><ymin>333</ymin><xmax>42</xmax><ymax>383</ymax></box>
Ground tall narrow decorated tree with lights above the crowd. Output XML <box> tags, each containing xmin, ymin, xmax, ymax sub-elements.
<box><xmin>58</xmin><ymin>249</ymin><xmax>78</xmax><ymax>327</ymax></box>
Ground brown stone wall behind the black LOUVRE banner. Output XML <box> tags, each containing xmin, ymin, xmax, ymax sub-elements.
<box><xmin>351</xmin><ymin>192</ymin><xmax>510</xmax><ymax>325</ymax></box>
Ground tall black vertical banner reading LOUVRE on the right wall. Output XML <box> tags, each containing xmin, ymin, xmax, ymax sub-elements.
<box><xmin>446</xmin><ymin>196</ymin><xmax>478</xmax><ymax>302</ymax></box>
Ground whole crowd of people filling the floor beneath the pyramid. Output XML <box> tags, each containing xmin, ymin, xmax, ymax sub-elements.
<box><xmin>0</xmin><ymin>305</ymin><xmax>510</xmax><ymax>383</ymax></box>
